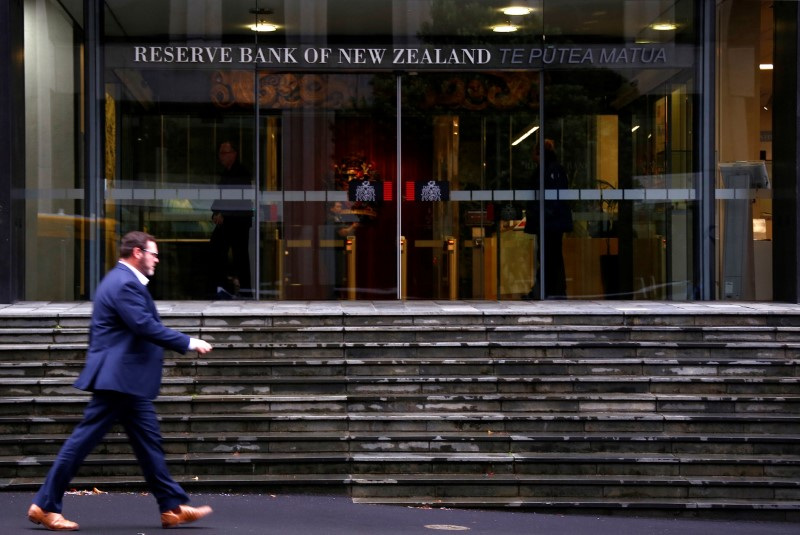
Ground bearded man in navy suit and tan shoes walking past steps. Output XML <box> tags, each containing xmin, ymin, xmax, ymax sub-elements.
<box><xmin>28</xmin><ymin>231</ymin><xmax>216</xmax><ymax>531</ymax></box>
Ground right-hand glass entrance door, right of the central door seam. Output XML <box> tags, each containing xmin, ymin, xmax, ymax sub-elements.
<box><xmin>400</xmin><ymin>72</ymin><xmax>539</xmax><ymax>299</ymax></box>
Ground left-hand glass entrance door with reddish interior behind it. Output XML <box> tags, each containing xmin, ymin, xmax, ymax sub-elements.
<box><xmin>258</xmin><ymin>71</ymin><xmax>398</xmax><ymax>300</ymax></box>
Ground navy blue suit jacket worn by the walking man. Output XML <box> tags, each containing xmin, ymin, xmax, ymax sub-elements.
<box><xmin>74</xmin><ymin>264</ymin><xmax>189</xmax><ymax>399</ymax></box>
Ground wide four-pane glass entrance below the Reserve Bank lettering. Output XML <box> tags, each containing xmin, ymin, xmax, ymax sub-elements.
<box><xmin>106</xmin><ymin>65</ymin><xmax>698</xmax><ymax>300</ymax></box>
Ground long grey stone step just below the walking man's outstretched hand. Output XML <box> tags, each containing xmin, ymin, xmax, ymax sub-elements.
<box><xmin>0</xmin><ymin>354</ymin><xmax>800</xmax><ymax>381</ymax></box>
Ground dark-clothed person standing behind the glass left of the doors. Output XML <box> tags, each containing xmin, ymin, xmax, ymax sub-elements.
<box><xmin>209</xmin><ymin>141</ymin><xmax>253</xmax><ymax>299</ymax></box>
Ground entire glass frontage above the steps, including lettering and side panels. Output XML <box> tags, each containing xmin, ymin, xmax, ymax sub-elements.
<box><xmin>9</xmin><ymin>0</ymin><xmax>786</xmax><ymax>300</ymax></box>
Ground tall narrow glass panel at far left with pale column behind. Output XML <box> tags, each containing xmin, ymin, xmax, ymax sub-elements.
<box><xmin>24</xmin><ymin>0</ymin><xmax>85</xmax><ymax>300</ymax></box>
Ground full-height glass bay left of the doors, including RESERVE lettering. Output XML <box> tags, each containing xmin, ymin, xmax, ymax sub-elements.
<box><xmin>104</xmin><ymin>1</ymin><xmax>259</xmax><ymax>299</ymax></box>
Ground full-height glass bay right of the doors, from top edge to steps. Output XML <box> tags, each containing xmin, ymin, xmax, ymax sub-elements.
<box><xmin>528</xmin><ymin>1</ymin><xmax>702</xmax><ymax>300</ymax></box>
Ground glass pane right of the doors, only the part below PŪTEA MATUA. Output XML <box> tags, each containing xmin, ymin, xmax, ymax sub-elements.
<box><xmin>542</xmin><ymin>70</ymin><xmax>701</xmax><ymax>300</ymax></box>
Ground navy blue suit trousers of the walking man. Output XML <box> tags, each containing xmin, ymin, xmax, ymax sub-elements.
<box><xmin>33</xmin><ymin>391</ymin><xmax>189</xmax><ymax>513</ymax></box>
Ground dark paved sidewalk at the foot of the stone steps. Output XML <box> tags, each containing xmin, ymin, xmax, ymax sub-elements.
<box><xmin>0</xmin><ymin>492</ymin><xmax>800</xmax><ymax>535</ymax></box>
